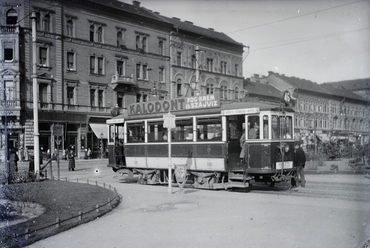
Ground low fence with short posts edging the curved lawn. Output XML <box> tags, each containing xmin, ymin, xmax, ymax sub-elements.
<box><xmin>9</xmin><ymin>178</ymin><xmax>122</xmax><ymax>240</ymax></box>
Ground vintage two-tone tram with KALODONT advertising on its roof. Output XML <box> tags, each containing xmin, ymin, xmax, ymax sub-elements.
<box><xmin>107</xmin><ymin>95</ymin><xmax>296</xmax><ymax>189</ymax></box>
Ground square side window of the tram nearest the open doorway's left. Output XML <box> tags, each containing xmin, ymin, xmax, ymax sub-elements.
<box><xmin>197</xmin><ymin>117</ymin><xmax>222</xmax><ymax>141</ymax></box>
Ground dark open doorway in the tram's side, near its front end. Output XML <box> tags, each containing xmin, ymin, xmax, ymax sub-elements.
<box><xmin>226</xmin><ymin>115</ymin><xmax>245</xmax><ymax>170</ymax></box>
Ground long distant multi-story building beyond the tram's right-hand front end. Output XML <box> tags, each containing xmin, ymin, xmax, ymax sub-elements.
<box><xmin>251</xmin><ymin>71</ymin><xmax>370</xmax><ymax>141</ymax></box>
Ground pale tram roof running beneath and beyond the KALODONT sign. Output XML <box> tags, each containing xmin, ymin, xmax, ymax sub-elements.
<box><xmin>107</xmin><ymin>102</ymin><xmax>294</xmax><ymax>124</ymax></box>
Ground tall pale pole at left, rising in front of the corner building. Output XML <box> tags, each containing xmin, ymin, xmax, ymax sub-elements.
<box><xmin>31</xmin><ymin>11</ymin><xmax>40</xmax><ymax>181</ymax></box>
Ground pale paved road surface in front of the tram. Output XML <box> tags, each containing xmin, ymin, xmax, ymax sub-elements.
<box><xmin>23</xmin><ymin>161</ymin><xmax>370</xmax><ymax>248</ymax></box>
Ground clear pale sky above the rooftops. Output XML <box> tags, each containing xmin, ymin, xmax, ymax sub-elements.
<box><xmin>123</xmin><ymin>0</ymin><xmax>370</xmax><ymax>84</ymax></box>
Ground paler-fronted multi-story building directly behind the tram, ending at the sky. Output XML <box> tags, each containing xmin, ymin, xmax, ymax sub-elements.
<box><xmin>156</xmin><ymin>13</ymin><xmax>244</xmax><ymax>100</ymax></box>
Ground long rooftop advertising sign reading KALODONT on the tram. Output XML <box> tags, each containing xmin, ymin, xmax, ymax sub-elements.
<box><xmin>128</xmin><ymin>95</ymin><xmax>220</xmax><ymax>115</ymax></box>
